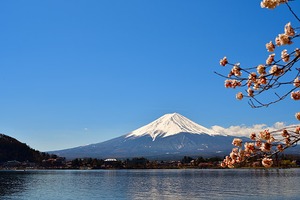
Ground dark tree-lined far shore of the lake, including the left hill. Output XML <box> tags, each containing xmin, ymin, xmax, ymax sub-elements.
<box><xmin>0</xmin><ymin>134</ymin><xmax>300</xmax><ymax>169</ymax></box>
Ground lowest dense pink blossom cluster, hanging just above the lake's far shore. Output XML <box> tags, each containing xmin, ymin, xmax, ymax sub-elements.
<box><xmin>221</xmin><ymin>126</ymin><xmax>300</xmax><ymax>168</ymax></box>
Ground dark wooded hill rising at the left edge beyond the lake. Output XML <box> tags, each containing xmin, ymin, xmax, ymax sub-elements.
<box><xmin>0</xmin><ymin>134</ymin><xmax>49</xmax><ymax>163</ymax></box>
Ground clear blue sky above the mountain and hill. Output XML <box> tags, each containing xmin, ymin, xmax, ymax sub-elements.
<box><xmin>0</xmin><ymin>0</ymin><xmax>300</xmax><ymax>151</ymax></box>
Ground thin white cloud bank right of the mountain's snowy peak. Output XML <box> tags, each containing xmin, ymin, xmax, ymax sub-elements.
<box><xmin>211</xmin><ymin>122</ymin><xmax>286</xmax><ymax>137</ymax></box>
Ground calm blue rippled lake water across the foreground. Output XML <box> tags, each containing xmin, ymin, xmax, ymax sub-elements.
<box><xmin>0</xmin><ymin>169</ymin><xmax>300</xmax><ymax>200</ymax></box>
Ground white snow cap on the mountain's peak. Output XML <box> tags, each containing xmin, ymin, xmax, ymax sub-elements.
<box><xmin>126</xmin><ymin>113</ymin><xmax>220</xmax><ymax>141</ymax></box>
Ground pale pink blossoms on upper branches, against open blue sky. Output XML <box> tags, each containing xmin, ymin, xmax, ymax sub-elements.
<box><xmin>220</xmin><ymin>18</ymin><xmax>300</xmax><ymax>119</ymax></box>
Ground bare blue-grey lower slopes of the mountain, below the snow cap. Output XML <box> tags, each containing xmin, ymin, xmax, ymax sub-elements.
<box><xmin>51</xmin><ymin>133</ymin><xmax>244</xmax><ymax>159</ymax></box>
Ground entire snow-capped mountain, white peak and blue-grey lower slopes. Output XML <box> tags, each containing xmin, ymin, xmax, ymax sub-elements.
<box><xmin>49</xmin><ymin>113</ymin><xmax>246</xmax><ymax>159</ymax></box>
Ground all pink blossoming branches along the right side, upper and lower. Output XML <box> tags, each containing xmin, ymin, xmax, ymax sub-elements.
<box><xmin>220</xmin><ymin>0</ymin><xmax>300</xmax><ymax>168</ymax></box>
